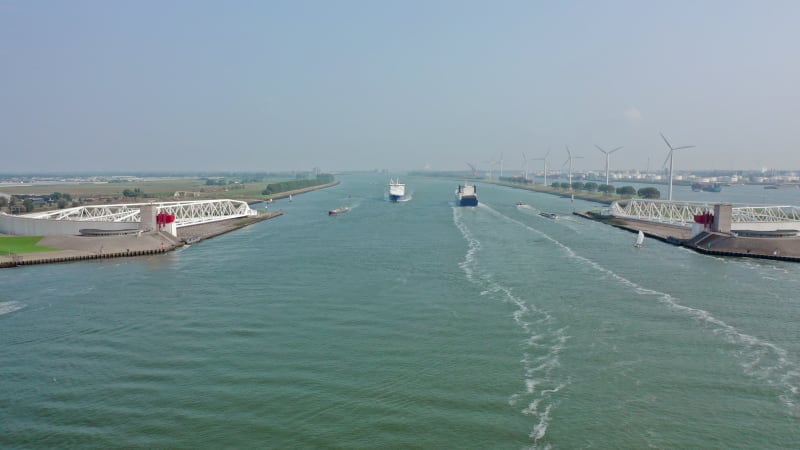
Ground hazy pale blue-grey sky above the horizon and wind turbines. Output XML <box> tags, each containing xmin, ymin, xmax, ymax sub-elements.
<box><xmin>0</xmin><ymin>0</ymin><xmax>800</xmax><ymax>172</ymax></box>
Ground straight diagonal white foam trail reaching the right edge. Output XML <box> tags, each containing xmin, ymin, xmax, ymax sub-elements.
<box><xmin>483</xmin><ymin>203</ymin><xmax>800</xmax><ymax>417</ymax></box>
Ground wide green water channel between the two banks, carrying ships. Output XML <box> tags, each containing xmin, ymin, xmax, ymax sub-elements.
<box><xmin>0</xmin><ymin>175</ymin><xmax>800</xmax><ymax>449</ymax></box>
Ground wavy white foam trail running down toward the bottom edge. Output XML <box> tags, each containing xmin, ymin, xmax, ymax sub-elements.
<box><xmin>453</xmin><ymin>206</ymin><xmax>569</xmax><ymax>448</ymax></box>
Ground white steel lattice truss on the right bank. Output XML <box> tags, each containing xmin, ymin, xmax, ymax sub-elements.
<box><xmin>609</xmin><ymin>199</ymin><xmax>800</xmax><ymax>230</ymax></box>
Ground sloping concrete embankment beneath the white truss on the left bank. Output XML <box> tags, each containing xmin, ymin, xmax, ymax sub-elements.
<box><xmin>0</xmin><ymin>211</ymin><xmax>283</xmax><ymax>267</ymax></box>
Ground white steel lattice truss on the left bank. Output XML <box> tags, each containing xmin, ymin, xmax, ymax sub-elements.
<box><xmin>27</xmin><ymin>200</ymin><xmax>258</xmax><ymax>228</ymax></box>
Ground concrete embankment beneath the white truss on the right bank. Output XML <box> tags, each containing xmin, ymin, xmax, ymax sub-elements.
<box><xmin>575</xmin><ymin>211</ymin><xmax>800</xmax><ymax>262</ymax></box>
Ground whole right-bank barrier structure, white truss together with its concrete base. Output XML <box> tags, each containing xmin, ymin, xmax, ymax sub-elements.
<box><xmin>576</xmin><ymin>199</ymin><xmax>800</xmax><ymax>262</ymax></box>
